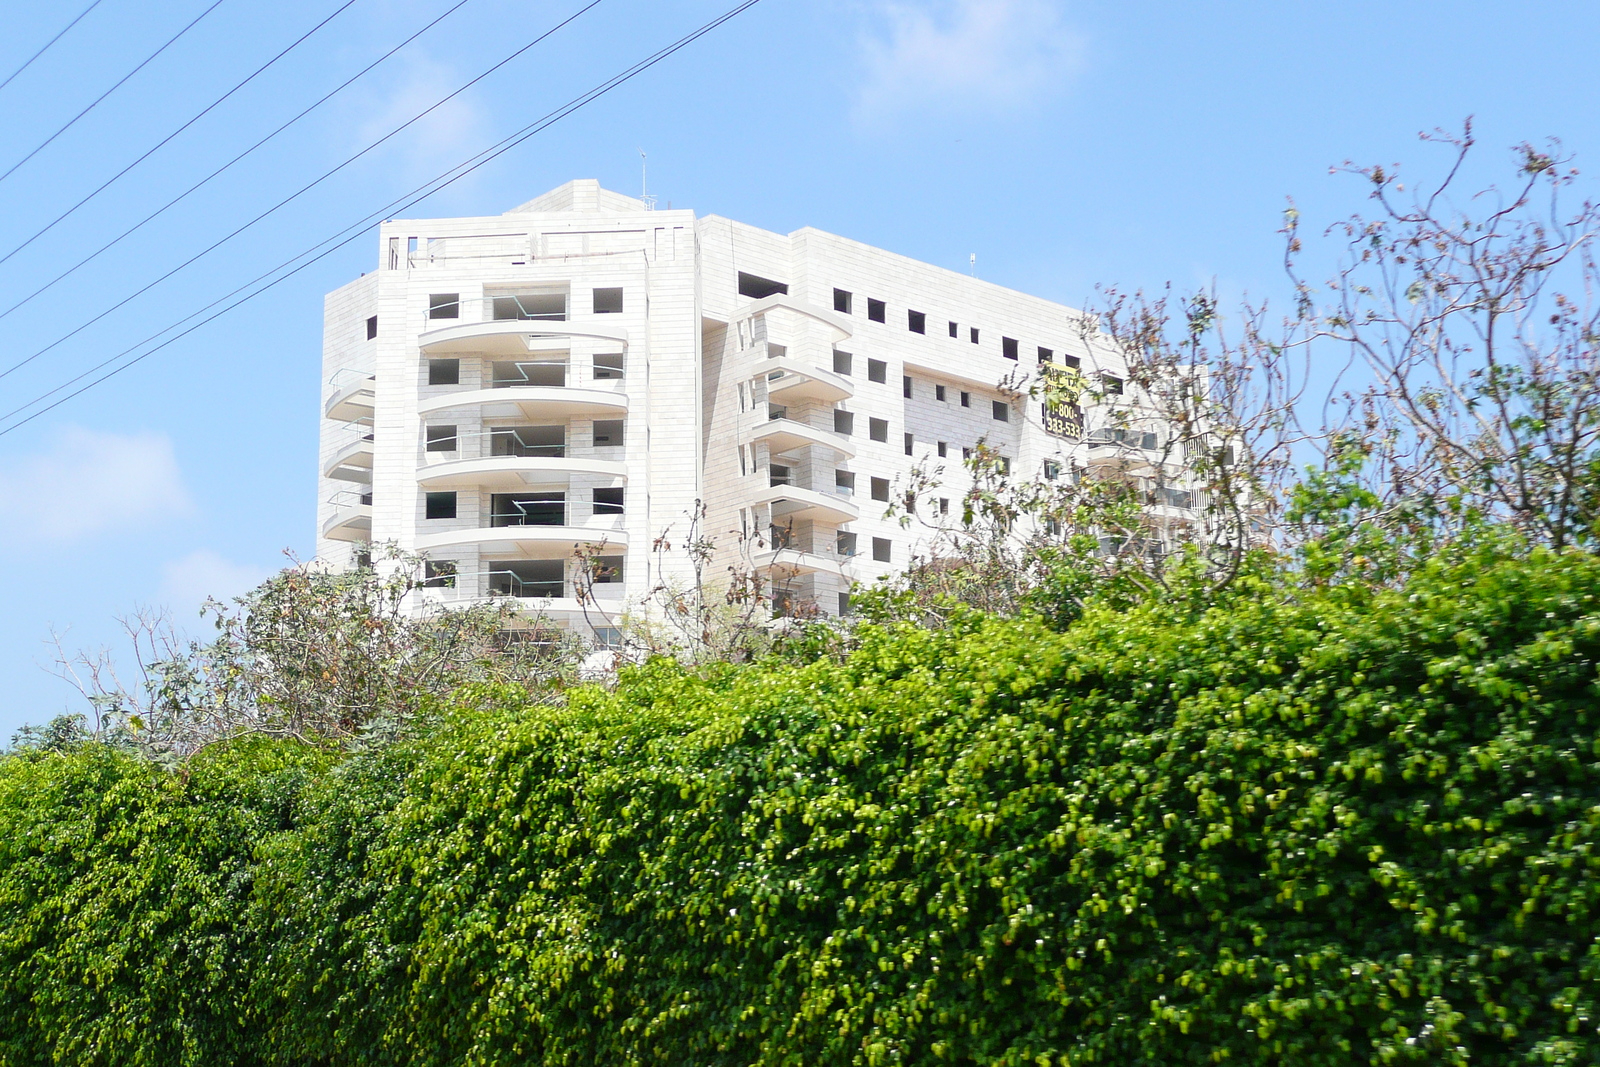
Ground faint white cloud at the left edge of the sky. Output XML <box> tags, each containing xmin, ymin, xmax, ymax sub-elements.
<box><xmin>0</xmin><ymin>426</ymin><xmax>192</xmax><ymax>544</ymax></box>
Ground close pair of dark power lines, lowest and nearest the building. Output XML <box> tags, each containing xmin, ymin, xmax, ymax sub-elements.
<box><xmin>0</xmin><ymin>0</ymin><xmax>760</xmax><ymax>437</ymax></box>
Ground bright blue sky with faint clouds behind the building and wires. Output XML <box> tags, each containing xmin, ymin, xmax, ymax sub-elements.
<box><xmin>0</xmin><ymin>0</ymin><xmax>1600</xmax><ymax>742</ymax></box>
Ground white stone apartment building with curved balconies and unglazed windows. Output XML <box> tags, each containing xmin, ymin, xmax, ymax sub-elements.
<box><xmin>317</xmin><ymin>181</ymin><xmax>1122</xmax><ymax>638</ymax></box>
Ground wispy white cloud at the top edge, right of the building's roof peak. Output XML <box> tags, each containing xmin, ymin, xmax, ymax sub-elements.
<box><xmin>856</xmin><ymin>0</ymin><xmax>1083</xmax><ymax>122</ymax></box>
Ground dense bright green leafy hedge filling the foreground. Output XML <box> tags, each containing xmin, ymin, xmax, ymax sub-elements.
<box><xmin>0</xmin><ymin>553</ymin><xmax>1600</xmax><ymax>1067</ymax></box>
